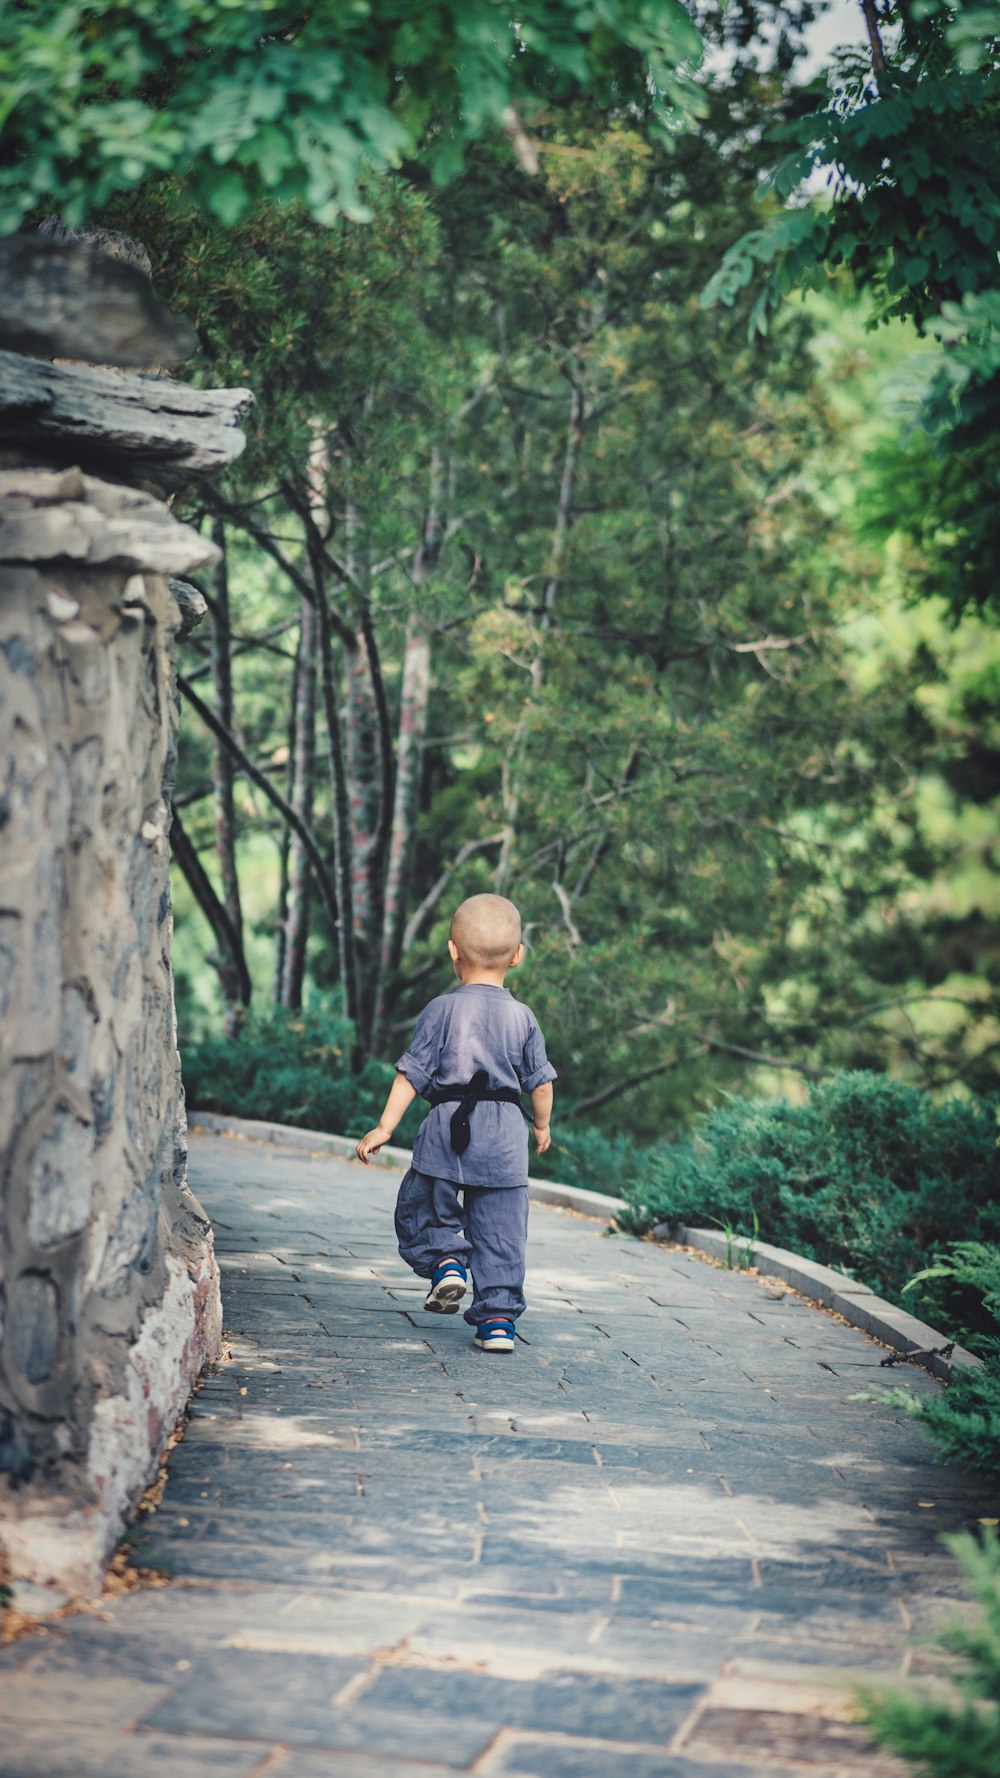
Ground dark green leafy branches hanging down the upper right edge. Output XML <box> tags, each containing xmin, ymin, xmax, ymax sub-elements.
<box><xmin>703</xmin><ymin>0</ymin><xmax>1000</xmax><ymax>613</ymax></box>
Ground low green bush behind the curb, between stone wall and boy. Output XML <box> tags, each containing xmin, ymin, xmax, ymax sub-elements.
<box><xmin>181</xmin><ymin>999</ymin><xmax>423</xmax><ymax>1147</ymax></box>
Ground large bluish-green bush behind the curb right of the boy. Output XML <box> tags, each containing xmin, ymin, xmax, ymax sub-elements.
<box><xmin>619</xmin><ymin>1074</ymin><xmax>1000</xmax><ymax>1334</ymax></box>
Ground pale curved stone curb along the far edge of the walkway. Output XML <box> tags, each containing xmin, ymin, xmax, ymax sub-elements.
<box><xmin>189</xmin><ymin>1109</ymin><xmax>982</xmax><ymax>1383</ymax></box>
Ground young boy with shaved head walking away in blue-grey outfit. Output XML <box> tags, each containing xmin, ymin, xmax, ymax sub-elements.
<box><xmin>356</xmin><ymin>894</ymin><xmax>555</xmax><ymax>1351</ymax></box>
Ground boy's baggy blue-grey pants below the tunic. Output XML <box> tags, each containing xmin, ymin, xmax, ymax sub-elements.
<box><xmin>395</xmin><ymin>1166</ymin><xmax>528</xmax><ymax>1326</ymax></box>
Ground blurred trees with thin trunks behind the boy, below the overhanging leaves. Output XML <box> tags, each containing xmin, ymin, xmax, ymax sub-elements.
<box><xmin>87</xmin><ymin>5</ymin><xmax>1000</xmax><ymax>1141</ymax></box>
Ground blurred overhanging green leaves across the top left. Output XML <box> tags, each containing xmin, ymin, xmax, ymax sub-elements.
<box><xmin>0</xmin><ymin>0</ymin><xmax>701</xmax><ymax>231</ymax></box>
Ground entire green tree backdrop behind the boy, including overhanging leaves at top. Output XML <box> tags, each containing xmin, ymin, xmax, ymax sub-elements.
<box><xmin>9</xmin><ymin>0</ymin><xmax>1000</xmax><ymax>1252</ymax></box>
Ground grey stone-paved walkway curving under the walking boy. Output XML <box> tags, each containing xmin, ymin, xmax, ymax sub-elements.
<box><xmin>0</xmin><ymin>1136</ymin><xmax>984</xmax><ymax>1778</ymax></box>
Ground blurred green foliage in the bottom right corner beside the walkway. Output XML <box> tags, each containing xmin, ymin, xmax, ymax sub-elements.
<box><xmin>863</xmin><ymin>1531</ymin><xmax>1000</xmax><ymax>1778</ymax></box>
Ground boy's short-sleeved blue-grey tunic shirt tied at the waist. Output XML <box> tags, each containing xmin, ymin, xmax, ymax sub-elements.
<box><xmin>397</xmin><ymin>981</ymin><xmax>557</xmax><ymax>1186</ymax></box>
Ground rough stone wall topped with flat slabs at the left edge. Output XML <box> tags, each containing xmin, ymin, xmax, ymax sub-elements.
<box><xmin>0</xmin><ymin>236</ymin><xmax>249</xmax><ymax>1595</ymax></box>
